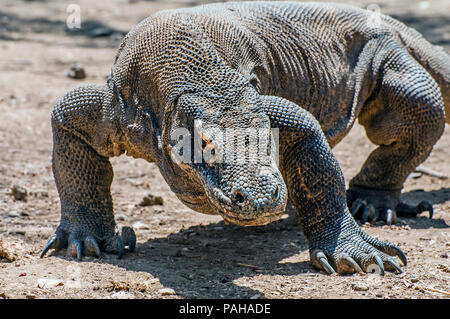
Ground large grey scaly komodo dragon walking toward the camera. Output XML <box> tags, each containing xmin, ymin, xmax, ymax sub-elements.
<box><xmin>41</xmin><ymin>2</ymin><xmax>450</xmax><ymax>274</ymax></box>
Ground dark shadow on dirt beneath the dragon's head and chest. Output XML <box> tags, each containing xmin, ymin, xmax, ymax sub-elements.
<box><xmin>103</xmin><ymin>218</ymin><xmax>317</xmax><ymax>298</ymax></box>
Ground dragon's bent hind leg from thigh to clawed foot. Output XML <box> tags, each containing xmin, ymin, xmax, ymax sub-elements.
<box><xmin>347</xmin><ymin>49</ymin><xmax>445</xmax><ymax>224</ymax></box>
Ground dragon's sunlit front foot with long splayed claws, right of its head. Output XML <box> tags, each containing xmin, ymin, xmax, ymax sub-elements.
<box><xmin>310</xmin><ymin>216</ymin><xmax>407</xmax><ymax>275</ymax></box>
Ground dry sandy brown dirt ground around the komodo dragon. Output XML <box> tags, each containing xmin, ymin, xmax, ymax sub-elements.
<box><xmin>0</xmin><ymin>0</ymin><xmax>450</xmax><ymax>298</ymax></box>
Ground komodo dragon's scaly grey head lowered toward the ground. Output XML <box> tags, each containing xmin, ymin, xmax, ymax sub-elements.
<box><xmin>165</xmin><ymin>86</ymin><xmax>287</xmax><ymax>226</ymax></box>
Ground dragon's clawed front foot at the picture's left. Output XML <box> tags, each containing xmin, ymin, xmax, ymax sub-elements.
<box><xmin>41</xmin><ymin>225</ymin><xmax>136</xmax><ymax>261</ymax></box>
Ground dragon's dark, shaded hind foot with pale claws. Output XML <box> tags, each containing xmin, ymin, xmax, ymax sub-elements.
<box><xmin>347</xmin><ymin>187</ymin><xmax>433</xmax><ymax>225</ymax></box>
